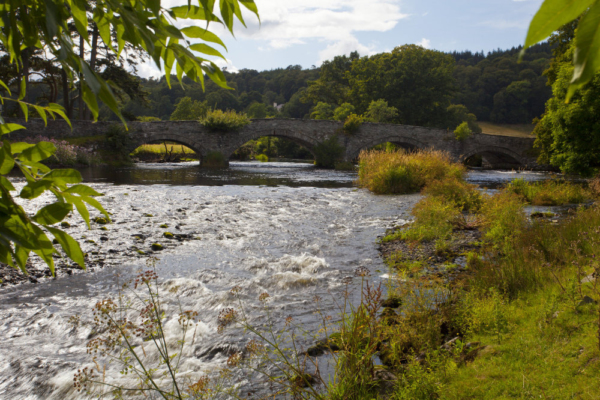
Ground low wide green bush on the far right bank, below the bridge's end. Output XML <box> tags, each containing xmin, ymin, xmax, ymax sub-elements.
<box><xmin>505</xmin><ymin>178</ymin><xmax>593</xmax><ymax>206</ymax></box>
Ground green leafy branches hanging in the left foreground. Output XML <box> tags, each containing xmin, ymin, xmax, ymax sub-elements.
<box><xmin>0</xmin><ymin>0</ymin><xmax>258</xmax><ymax>273</ymax></box>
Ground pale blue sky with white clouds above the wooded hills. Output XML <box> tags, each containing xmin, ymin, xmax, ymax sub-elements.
<box><xmin>138</xmin><ymin>0</ymin><xmax>543</xmax><ymax>77</ymax></box>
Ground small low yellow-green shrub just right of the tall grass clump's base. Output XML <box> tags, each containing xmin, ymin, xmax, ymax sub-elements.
<box><xmin>423</xmin><ymin>178</ymin><xmax>483</xmax><ymax>212</ymax></box>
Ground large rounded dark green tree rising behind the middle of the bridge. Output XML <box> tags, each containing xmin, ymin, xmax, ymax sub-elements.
<box><xmin>348</xmin><ymin>45</ymin><xmax>454</xmax><ymax>126</ymax></box>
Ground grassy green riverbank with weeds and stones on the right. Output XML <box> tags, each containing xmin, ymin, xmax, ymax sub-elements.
<box><xmin>326</xmin><ymin>152</ymin><xmax>600</xmax><ymax>399</ymax></box>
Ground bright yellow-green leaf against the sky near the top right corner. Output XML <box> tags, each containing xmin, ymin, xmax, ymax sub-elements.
<box><xmin>525</xmin><ymin>0</ymin><xmax>596</xmax><ymax>48</ymax></box>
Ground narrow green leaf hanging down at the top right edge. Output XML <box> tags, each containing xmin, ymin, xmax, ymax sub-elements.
<box><xmin>567</xmin><ymin>1</ymin><xmax>600</xmax><ymax>101</ymax></box>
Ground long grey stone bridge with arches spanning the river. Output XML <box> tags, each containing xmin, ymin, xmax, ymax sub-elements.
<box><xmin>5</xmin><ymin>119</ymin><xmax>542</xmax><ymax>169</ymax></box>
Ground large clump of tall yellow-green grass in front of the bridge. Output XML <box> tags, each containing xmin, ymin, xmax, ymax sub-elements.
<box><xmin>358</xmin><ymin>150</ymin><xmax>466</xmax><ymax>194</ymax></box>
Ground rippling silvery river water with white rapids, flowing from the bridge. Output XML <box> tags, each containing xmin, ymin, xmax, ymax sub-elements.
<box><xmin>0</xmin><ymin>162</ymin><xmax>546</xmax><ymax>399</ymax></box>
